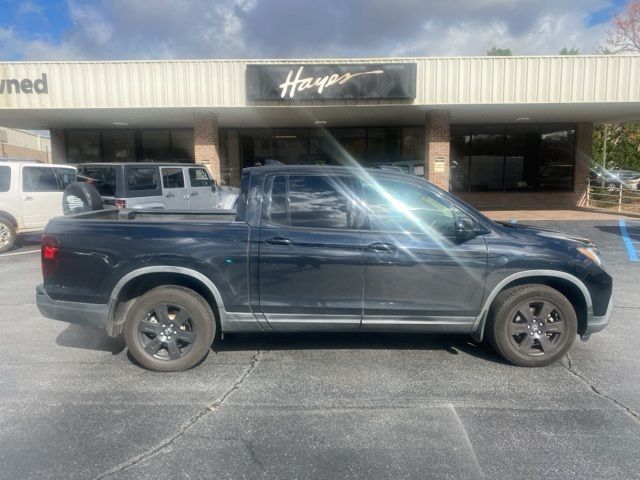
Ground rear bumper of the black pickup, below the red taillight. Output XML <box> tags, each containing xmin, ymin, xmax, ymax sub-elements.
<box><xmin>36</xmin><ymin>285</ymin><xmax>109</xmax><ymax>329</ymax></box>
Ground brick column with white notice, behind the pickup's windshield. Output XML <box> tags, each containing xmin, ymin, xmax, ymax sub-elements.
<box><xmin>424</xmin><ymin>110</ymin><xmax>451</xmax><ymax>191</ymax></box>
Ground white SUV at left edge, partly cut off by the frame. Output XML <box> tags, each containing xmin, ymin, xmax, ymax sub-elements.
<box><xmin>0</xmin><ymin>158</ymin><xmax>76</xmax><ymax>252</ymax></box>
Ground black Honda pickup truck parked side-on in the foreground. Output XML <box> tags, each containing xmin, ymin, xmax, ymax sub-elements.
<box><xmin>36</xmin><ymin>165</ymin><xmax>613</xmax><ymax>371</ymax></box>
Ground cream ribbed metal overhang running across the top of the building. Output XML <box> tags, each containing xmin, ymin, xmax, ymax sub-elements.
<box><xmin>0</xmin><ymin>55</ymin><xmax>640</xmax><ymax>129</ymax></box>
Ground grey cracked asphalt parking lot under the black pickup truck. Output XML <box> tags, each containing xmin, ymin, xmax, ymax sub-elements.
<box><xmin>0</xmin><ymin>220</ymin><xmax>640</xmax><ymax>479</ymax></box>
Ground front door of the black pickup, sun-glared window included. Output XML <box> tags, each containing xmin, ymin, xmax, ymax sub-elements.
<box><xmin>361</xmin><ymin>177</ymin><xmax>487</xmax><ymax>331</ymax></box>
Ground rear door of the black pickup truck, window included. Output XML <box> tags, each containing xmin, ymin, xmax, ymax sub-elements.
<box><xmin>259</xmin><ymin>174</ymin><xmax>363</xmax><ymax>330</ymax></box>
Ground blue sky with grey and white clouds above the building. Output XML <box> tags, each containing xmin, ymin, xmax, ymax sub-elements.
<box><xmin>0</xmin><ymin>0</ymin><xmax>625</xmax><ymax>61</ymax></box>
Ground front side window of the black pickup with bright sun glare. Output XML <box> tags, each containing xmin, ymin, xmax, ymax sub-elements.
<box><xmin>363</xmin><ymin>179</ymin><xmax>454</xmax><ymax>235</ymax></box>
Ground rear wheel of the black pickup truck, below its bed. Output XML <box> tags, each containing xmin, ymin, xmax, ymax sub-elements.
<box><xmin>124</xmin><ymin>286</ymin><xmax>216</xmax><ymax>372</ymax></box>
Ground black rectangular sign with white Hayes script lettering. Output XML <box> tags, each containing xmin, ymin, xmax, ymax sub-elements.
<box><xmin>246</xmin><ymin>63</ymin><xmax>416</xmax><ymax>100</ymax></box>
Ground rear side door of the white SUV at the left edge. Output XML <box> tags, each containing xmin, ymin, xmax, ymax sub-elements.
<box><xmin>20</xmin><ymin>165</ymin><xmax>63</xmax><ymax>229</ymax></box>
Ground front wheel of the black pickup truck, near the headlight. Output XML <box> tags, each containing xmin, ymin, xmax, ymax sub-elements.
<box><xmin>487</xmin><ymin>284</ymin><xmax>578</xmax><ymax>367</ymax></box>
